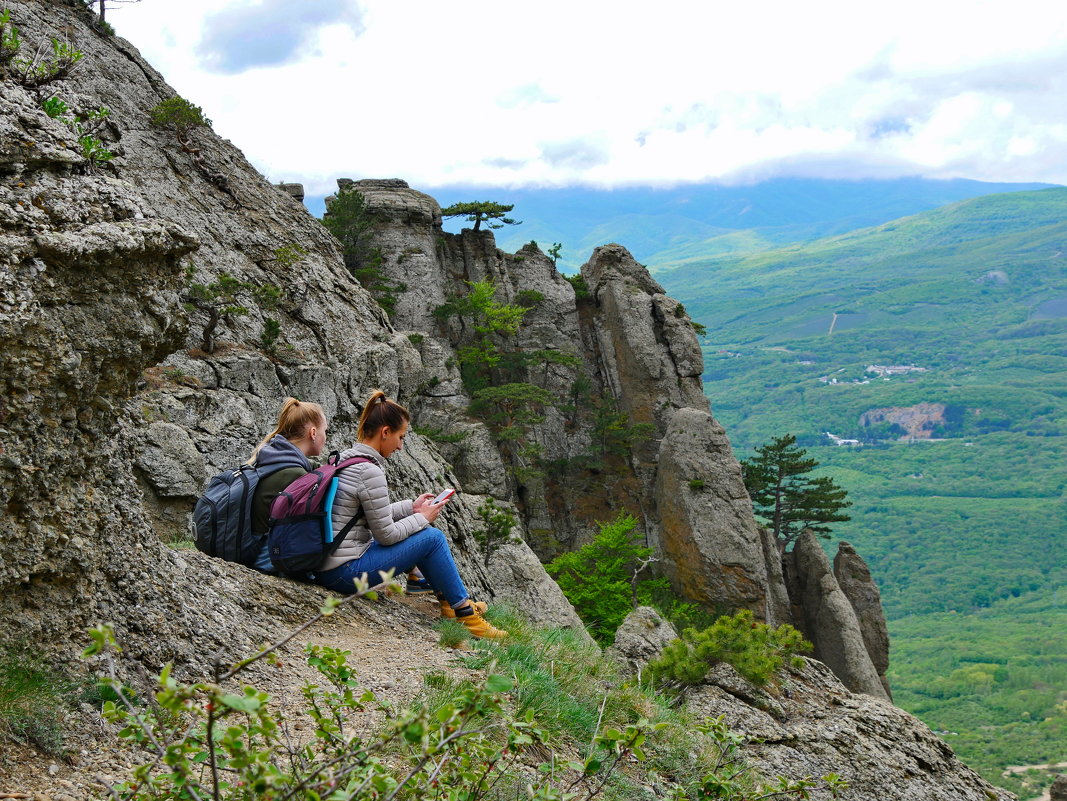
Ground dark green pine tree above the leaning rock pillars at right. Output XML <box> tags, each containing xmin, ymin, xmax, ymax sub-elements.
<box><xmin>740</xmin><ymin>434</ymin><xmax>853</xmax><ymax>550</ymax></box>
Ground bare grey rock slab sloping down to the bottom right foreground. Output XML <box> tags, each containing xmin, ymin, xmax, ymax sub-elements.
<box><xmin>686</xmin><ymin>660</ymin><xmax>1014</xmax><ymax>801</ymax></box>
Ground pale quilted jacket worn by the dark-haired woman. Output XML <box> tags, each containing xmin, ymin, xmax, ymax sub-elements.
<box><xmin>318</xmin><ymin>443</ymin><xmax>430</xmax><ymax>573</ymax></box>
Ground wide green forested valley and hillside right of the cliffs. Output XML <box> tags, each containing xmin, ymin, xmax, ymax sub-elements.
<box><xmin>653</xmin><ymin>189</ymin><xmax>1067</xmax><ymax>797</ymax></box>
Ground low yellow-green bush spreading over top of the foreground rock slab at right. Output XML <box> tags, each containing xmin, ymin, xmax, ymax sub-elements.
<box><xmin>649</xmin><ymin>609</ymin><xmax>811</xmax><ymax>686</ymax></box>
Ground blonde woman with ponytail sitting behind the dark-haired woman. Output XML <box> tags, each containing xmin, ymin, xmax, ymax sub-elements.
<box><xmin>248</xmin><ymin>398</ymin><xmax>327</xmax><ymax>573</ymax></box>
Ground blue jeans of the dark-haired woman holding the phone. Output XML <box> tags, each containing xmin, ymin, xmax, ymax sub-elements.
<box><xmin>315</xmin><ymin>526</ymin><xmax>469</xmax><ymax>607</ymax></box>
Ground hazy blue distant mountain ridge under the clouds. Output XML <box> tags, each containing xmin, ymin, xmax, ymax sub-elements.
<box><xmin>307</xmin><ymin>178</ymin><xmax>1049</xmax><ymax>272</ymax></box>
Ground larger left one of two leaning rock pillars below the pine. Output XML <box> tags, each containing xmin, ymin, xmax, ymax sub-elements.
<box><xmin>787</xmin><ymin>531</ymin><xmax>889</xmax><ymax>701</ymax></box>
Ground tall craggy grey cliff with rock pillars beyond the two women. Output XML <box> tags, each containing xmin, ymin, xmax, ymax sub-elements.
<box><xmin>352</xmin><ymin>180</ymin><xmax>786</xmax><ymax>622</ymax></box>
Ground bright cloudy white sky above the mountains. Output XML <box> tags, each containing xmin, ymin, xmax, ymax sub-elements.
<box><xmin>109</xmin><ymin>0</ymin><xmax>1067</xmax><ymax>194</ymax></box>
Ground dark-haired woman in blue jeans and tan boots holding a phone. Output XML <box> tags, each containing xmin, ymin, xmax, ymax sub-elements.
<box><xmin>315</xmin><ymin>391</ymin><xmax>508</xmax><ymax>640</ymax></box>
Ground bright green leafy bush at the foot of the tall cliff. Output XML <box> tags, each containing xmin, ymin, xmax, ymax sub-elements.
<box><xmin>545</xmin><ymin>514</ymin><xmax>667</xmax><ymax>645</ymax></box>
